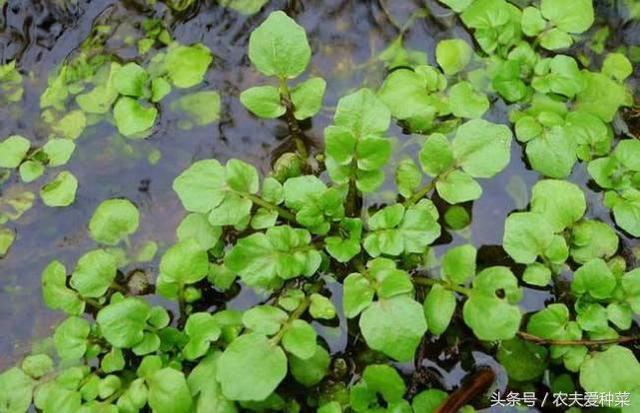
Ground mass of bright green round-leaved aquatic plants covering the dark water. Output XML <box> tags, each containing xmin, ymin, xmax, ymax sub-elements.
<box><xmin>0</xmin><ymin>0</ymin><xmax>640</xmax><ymax>413</ymax></box>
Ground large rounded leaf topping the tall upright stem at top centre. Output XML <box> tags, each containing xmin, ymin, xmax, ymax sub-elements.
<box><xmin>249</xmin><ymin>11</ymin><xmax>311</xmax><ymax>79</ymax></box>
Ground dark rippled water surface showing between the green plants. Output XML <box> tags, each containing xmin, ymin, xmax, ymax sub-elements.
<box><xmin>0</xmin><ymin>0</ymin><xmax>640</xmax><ymax>406</ymax></box>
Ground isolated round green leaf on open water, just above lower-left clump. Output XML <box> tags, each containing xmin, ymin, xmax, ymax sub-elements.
<box><xmin>89</xmin><ymin>199</ymin><xmax>140</xmax><ymax>245</ymax></box>
